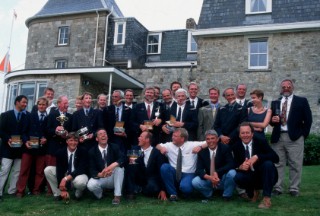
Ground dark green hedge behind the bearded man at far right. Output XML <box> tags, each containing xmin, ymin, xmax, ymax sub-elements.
<box><xmin>266</xmin><ymin>134</ymin><xmax>320</xmax><ymax>166</ymax></box>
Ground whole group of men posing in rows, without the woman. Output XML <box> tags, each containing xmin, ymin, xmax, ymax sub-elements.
<box><xmin>0</xmin><ymin>79</ymin><xmax>312</xmax><ymax>208</ymax></box>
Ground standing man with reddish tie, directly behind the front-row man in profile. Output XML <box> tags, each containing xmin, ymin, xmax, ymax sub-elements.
<box><xmin>130</xmin><ymin>87</ymin><xmax>165</xmax><ymax>146</ymax></box>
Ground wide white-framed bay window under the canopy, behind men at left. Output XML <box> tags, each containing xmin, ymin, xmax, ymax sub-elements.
<box><xmin>7</xmin><ymin>81</ymin><xmax>48</xmax><ymax>111</ymax></box>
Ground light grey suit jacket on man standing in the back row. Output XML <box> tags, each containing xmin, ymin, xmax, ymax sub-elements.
<box><xmin>197</xmin><ymin>105</ymin><xmax>218</xmax><ymax>141</ymax></box>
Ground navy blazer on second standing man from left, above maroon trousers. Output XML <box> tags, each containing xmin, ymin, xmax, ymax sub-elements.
<box><xmin>23</xmin><ymin>111</ymin><xmax>48</xmax><ymax>155</ymax></box>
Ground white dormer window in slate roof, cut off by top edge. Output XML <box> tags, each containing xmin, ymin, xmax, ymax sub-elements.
<box><xmin>246</xmin><ymin>0</ymin><xmax>272</xmax><ymax>14</ymax></box>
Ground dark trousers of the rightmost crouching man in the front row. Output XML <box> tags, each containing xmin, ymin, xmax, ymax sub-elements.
<box><xmin>234</xmin><ymin>161</ymin><xmax>278</xmax><ymax>197</ymax></box>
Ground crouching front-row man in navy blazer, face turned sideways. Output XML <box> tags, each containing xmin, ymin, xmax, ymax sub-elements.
<box><xmin>126</xmin><ymin>131</ymin><xmax>167</xmax><ymax>200</ymax></box>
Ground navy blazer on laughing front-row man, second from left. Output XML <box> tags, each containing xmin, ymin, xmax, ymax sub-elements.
<box><xmin>89</xmin><ymin>143</ymin><xmax>125</xmax><ymax>178</ymax></box>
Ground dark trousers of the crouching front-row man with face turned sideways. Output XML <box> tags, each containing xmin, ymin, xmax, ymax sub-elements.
<box><xmin>126</xmin><ymin>164</ymin><xmax>161</xmax><ymax>196</ymax></box>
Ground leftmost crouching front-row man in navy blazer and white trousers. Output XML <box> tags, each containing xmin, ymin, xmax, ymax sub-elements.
<box><xmin>44</xmin><ymin>133</ymin><xmax>88</xmax><ymax>201</ymax></box>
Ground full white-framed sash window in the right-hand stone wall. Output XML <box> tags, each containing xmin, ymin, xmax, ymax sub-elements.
<box><xmin>248</xmin><ymin>38</ymin><xmax>268</xmax><ymax>69</ymax></box>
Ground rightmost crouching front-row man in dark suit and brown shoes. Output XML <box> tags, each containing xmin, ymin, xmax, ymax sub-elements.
<box><xmin>233</xmin><ymin>122</ymin><xmax>279</xmax><ymax>209</ymax></box>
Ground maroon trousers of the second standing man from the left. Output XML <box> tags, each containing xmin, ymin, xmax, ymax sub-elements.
<box><xmin>17</xmin><ymin>153</ymin><xmax>45</xmax><ymax>194</ymax></box>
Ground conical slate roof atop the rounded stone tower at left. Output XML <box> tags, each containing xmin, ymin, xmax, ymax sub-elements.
<box><xmin>26</xmin><ymin>0</ymin><xmax>123</xmax><ymax>26</ymax></box>
